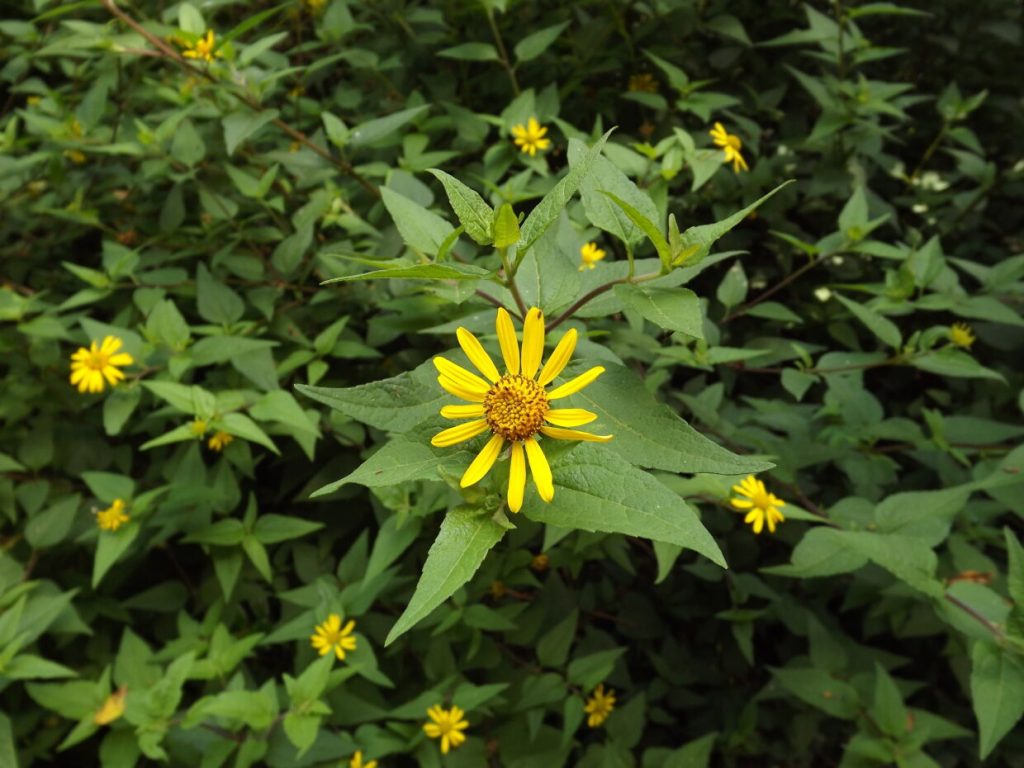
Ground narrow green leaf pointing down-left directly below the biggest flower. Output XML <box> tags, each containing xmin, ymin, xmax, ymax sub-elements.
<box><xmin>384</xmin><ymin>507</ymin><xmax>505</xmax><ymax>646</ymax></box>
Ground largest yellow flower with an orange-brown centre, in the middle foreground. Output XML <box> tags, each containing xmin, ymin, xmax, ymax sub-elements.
<box><xmin>430</xmin><ymin>307</ymin><xmax>611</xmax><ymax>512</ymax></box>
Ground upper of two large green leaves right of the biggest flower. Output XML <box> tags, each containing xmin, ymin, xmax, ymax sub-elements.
<box><xmin>564</xmin><ymin>365</ymin><xmax>774</xmax><ymax>475</ymax></box>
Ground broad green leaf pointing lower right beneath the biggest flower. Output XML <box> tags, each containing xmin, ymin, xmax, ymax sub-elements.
<box><xmin>523</xmin><ymin>443</ymin><xmax>726</xmax><ymax>567</ymax></box>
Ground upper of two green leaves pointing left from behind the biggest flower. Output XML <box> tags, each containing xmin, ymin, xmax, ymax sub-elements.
<box><xmin>295</xmin><ymin>360</ymin><xmax>452</xmax><ymax>433</ymax></box>
